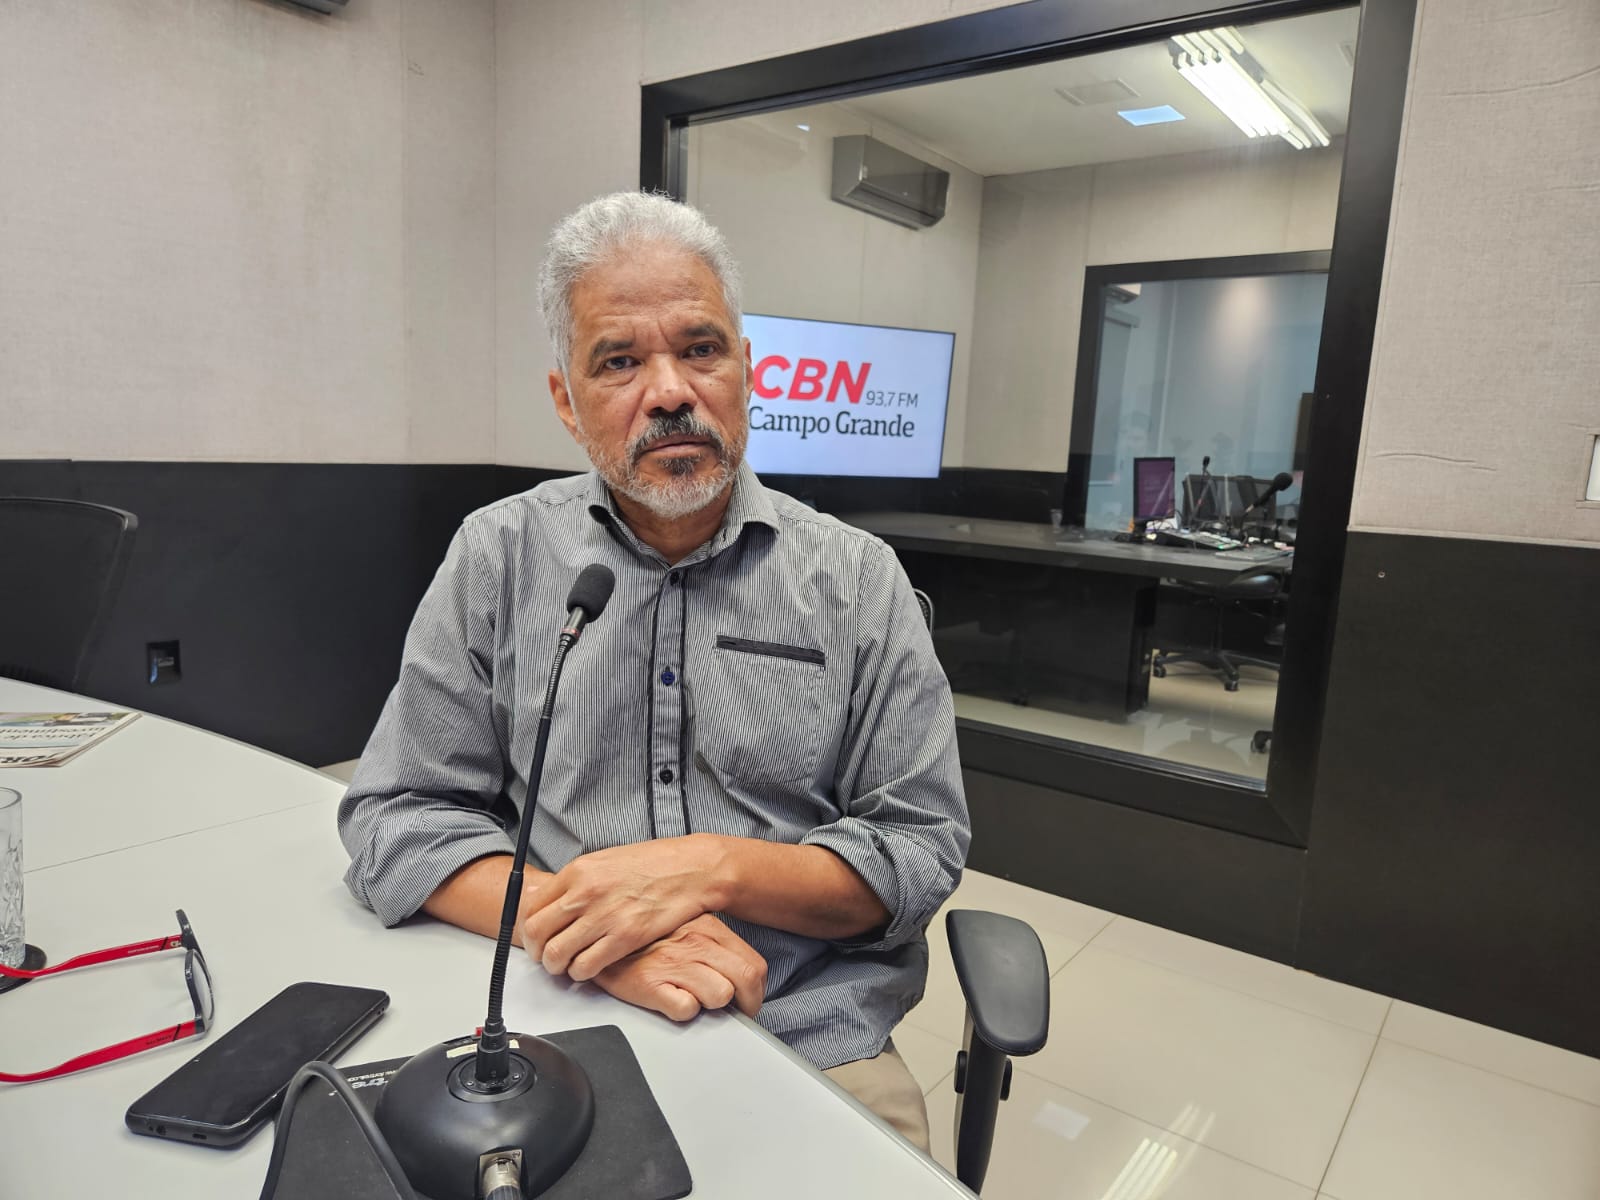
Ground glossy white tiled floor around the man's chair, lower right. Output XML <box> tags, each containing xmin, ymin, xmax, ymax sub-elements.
<box><xmin>894</xmin><ymin>872</ymin><xmax>1600</xmax><ymax>1200</ymax></box>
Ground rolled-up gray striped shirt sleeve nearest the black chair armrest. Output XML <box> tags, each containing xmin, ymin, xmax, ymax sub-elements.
<box><xmin>802</xmin><ymin>542</ymin><xmax>971</xmax><ymax>950</ymax></box>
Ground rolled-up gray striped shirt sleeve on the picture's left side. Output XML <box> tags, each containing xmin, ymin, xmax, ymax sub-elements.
<box><xmin>339</xmin><ymin>525</ymin><xmax>514</xmax><ymax>925</ymax></box>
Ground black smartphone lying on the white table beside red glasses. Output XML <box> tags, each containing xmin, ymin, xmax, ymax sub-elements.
<box><xmin>125</xmin><ymin>984</ymin><xmax>389</xmax><ymax>1146</ymax></box>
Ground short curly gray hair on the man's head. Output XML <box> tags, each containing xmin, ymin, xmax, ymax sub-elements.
<box><xmin>539</xmin><ymin>192</ymin><xmax>744</xmax><ymax>376</ymax></box>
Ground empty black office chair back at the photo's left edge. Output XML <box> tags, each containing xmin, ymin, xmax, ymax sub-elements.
<box><xmin>0</xmin><ymin>496</ymin><xmax>139</xmax><ymax>691</ymax></box>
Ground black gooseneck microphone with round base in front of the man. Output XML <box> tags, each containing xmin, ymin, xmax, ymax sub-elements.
<box><xmin>376</xmin><ymin>563</ymin><xmax>616</xmax><ymax>1200</ymax></box>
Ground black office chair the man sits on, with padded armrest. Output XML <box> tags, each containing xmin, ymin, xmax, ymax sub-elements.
<box><xmin>912</xmin><ymin>589</ymin><xmax>1050</xmax><ymax>1192</ymax></box>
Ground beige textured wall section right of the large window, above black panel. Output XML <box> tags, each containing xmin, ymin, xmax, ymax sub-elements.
<box><xmin>1350</xmin><ymin>0</ymin><xmax>1600</xmax><ymax>550</ymax></box>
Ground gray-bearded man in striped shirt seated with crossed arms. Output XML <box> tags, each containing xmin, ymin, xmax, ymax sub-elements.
<box><xmin>339</xmin><ymin>192</ymin><xmax>970</xmax><ymax>1149</ymax></box>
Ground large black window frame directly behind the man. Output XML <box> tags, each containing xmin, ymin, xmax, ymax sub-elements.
<box><xmin>640</xmin><ymin>0</ymin><xmax>1416</xmax><ymax>846</ymax></box>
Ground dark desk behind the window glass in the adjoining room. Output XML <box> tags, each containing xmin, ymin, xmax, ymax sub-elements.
<box><xmin>840</xmin><ymin>512</ymin><xmax>1293</xmax><ymax>718</ymax></box>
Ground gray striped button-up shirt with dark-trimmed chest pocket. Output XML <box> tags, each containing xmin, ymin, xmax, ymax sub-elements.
<box><xmin>339</xmin><ymin>466</ymin><xmax>970</xmax><ymax>1067</ymax></box>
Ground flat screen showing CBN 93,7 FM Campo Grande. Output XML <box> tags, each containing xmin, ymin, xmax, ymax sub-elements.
<box><xmin>744</xmin><ymin>314</ymin><xmax>955</xmax><ymax>478</ymax></box>
